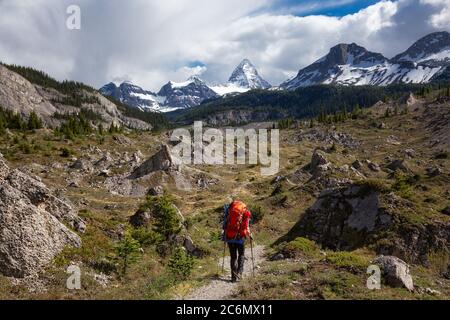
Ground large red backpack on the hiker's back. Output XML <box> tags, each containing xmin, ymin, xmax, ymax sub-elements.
<box><xmin>225</xmin><ymin>201</ymin><xmax>250</xmax><ymax>240</ymax></box>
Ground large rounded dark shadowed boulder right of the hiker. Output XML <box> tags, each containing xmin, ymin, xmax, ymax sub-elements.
<box><xmin>287</xmin><ymin>185</ymin><xmax>392</xmax><ymax>250</ymax></box>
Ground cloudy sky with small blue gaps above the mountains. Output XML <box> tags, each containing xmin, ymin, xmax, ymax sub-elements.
<box><xmin>0</xmin><ymin>0</ymin><xmax>450</xmax><ymax>91</ymax></box>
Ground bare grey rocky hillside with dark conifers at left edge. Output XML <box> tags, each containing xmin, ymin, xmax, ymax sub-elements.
<box><xmin>0</xmin><ymin>64</ymin><xmax>167</xmax><ymax>130</ymax></box>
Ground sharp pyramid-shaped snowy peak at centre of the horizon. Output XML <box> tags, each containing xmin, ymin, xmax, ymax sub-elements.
<box><xmin>228</xmin><ymin>58</ymin><xmax>271</xmax><ymax>89</ymax></box>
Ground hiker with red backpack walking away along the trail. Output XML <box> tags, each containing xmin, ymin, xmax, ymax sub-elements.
<box><xmin>223</xmin><ymin>200</ymin><xmax>253</xmax><ymax>282</ymax></box>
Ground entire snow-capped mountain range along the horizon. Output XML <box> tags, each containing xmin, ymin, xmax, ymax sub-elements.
<box><xmin>100</xmin><ymin>32</ymin><xmax>450</xmax><ymax>112</ymax></box>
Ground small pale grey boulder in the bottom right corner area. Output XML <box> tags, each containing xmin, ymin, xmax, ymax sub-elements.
<box><xmin>373</xmin><ymin>256</ymin><xmax>414</xmax><ymax>291</ymax></box>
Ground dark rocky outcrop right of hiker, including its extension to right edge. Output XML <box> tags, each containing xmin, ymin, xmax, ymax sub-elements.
<box><xmin>278</xmin><ymin>184</ymin><xmax>450</xmax><ymax>264</ymax></box>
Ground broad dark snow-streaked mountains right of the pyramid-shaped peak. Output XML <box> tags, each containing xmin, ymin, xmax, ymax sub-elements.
<box><xmin>280</xmin><ymin>32</ymin><xmax>450</xmax><ymax>90</ymax></box>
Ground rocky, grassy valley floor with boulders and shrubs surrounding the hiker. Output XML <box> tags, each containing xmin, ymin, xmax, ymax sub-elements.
<box><xmin>0</xmin><ymin>80</ymin><xmax>450</xmax><ymax>299</ymax></box>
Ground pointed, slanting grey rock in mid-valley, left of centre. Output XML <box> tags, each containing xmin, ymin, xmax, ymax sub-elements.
<box><xmin>130</xmin><ymin>144</ymin><xmax>176</xmax><ymax>179</ymax></box>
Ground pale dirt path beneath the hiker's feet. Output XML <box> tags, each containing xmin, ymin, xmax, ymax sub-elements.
<box><xmin>184</xmin><ymin>246</ymin><xmax>265</xmax><ymax>300</ymax></box>
